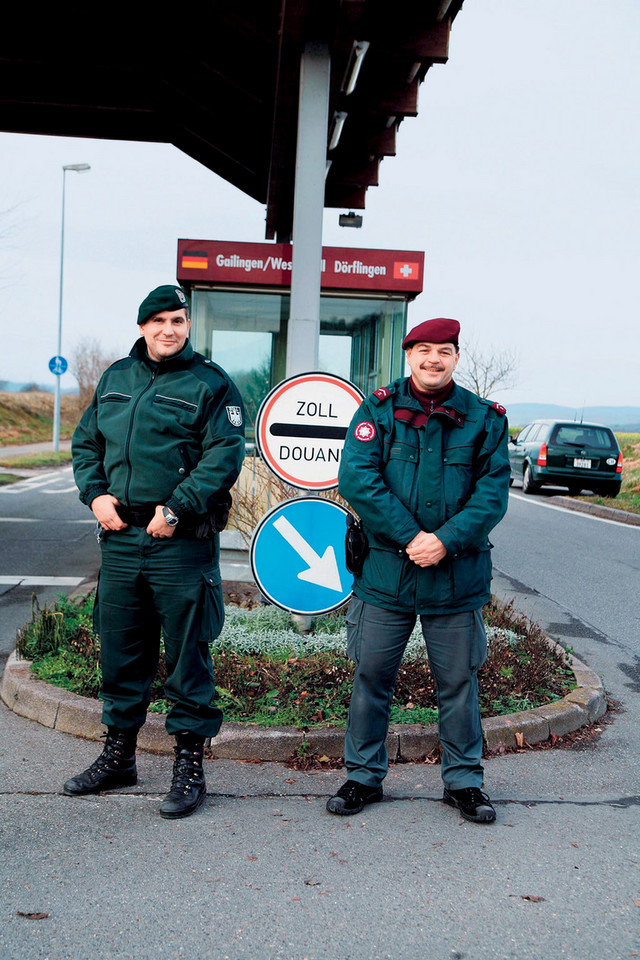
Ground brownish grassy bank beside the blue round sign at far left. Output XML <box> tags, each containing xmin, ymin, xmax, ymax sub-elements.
<box><xmin>0</xmin><ymin>391</ymin><xmax>79</xmax><ymax>446</ymax></box>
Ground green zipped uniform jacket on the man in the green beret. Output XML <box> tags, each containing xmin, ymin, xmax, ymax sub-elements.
<box><xmin>72</xmin><ymin>338</ymin><xmax>244</xmax><ymax>520</ymax></box>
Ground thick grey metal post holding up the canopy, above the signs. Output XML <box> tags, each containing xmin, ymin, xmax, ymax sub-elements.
<box><xmin>286</xmin><ymin>43</ymin><xmax>330</xmax><ymax>377</ymax></box>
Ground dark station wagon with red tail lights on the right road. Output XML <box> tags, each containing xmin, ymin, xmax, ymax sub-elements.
<box><xmin>509</xmin><ymin>420</ymin><xmax>622</xmax><ymax>497</ymax></box>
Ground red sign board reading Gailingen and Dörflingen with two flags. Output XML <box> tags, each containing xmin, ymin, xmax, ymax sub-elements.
<box><xmin>177</xmin><ymin>240</ymin><xmax>424</xmax><ymax>296</ymax></box>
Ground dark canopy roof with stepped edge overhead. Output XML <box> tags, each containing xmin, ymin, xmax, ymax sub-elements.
<box><xmin>0</xmin><ymin>0</ymin><xmax>462</xmax><ymax>240</ymax></box>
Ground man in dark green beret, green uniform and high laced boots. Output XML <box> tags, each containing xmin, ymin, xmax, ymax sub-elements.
<box><xmin>63</xmin><ymin>285</ymin><xmax>244</xmax><ymax>818</ymax></box>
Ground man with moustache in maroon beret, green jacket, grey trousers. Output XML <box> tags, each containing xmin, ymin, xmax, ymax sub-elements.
<box><xmin>327</xmin><ymin>318</ymin><xmax>510</xmax><ymax>822</ymax></box>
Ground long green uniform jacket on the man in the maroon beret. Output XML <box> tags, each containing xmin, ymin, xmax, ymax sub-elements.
<box><xmin>339</xmin><ymin>378</ymin><xmax>510</xmax><ymax>614</ymax></box>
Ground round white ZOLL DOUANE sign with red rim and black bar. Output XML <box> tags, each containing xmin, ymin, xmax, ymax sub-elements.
<box><xmin>256</xmin><ymin>373</ymin><xmax>364</xmax><ymax>490</ymax></box>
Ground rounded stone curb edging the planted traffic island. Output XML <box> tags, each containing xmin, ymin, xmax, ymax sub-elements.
<box><xmin>0</xmin><ymin>640</ymin><xmax>607</xmax><ymax>761</ymax></box>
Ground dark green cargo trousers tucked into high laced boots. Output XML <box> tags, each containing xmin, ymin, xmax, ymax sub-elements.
<box><xmin>94</xmin><ymin>526</ymin><xmax>224</xmax><ymax>737</ymax></box>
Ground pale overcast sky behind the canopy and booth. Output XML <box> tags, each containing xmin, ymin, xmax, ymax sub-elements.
<box><xmin>0</xmin><ymin>0</ymin><xmax>640</xmax><ymax>407</ymax></box>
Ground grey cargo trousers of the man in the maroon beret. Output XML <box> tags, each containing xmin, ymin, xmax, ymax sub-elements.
<box><xmin>345</xmin><ymin>597</ymin><xmax>487</xmax><ymax>790</ymax></box>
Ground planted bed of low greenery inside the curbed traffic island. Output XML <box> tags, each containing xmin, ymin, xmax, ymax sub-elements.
<box><xmin>18</xmin><ymin>596</ymin><xmax>573</xmax><ymax>728</ymax></box>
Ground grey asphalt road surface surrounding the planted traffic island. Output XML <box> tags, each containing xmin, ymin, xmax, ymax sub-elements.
<box><xmin>0</xmin><ymin>472</ymin><xmax>640</xmax><ymax>960</ymax></box>
